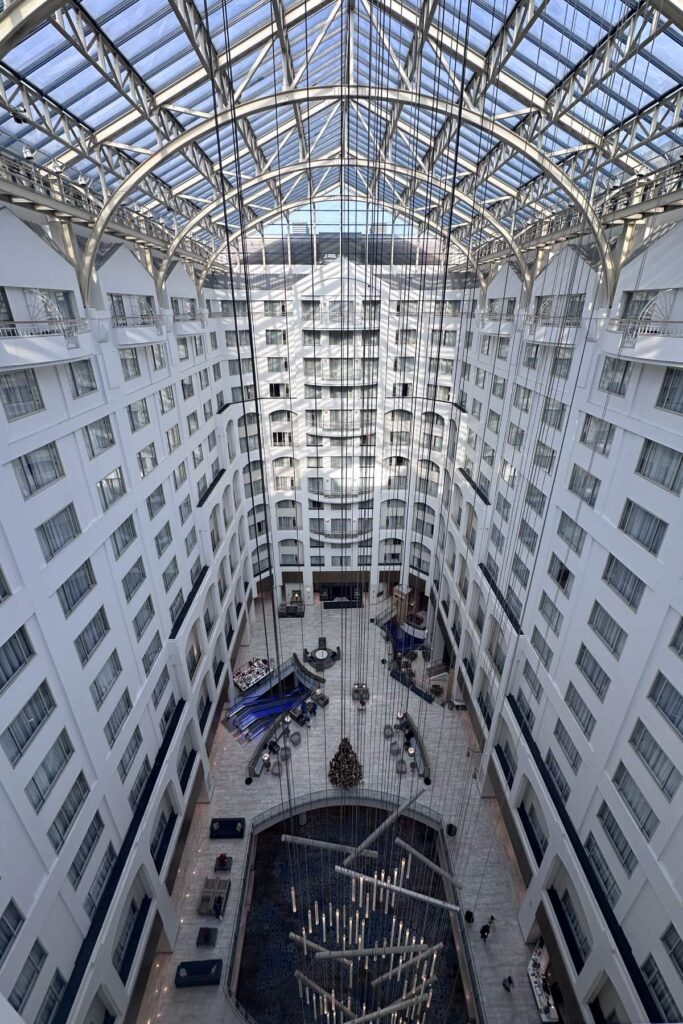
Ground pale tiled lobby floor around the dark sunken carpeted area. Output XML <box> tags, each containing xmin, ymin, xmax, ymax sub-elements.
<box><xmin>138</xmin><ymin>601</ymin><xmax>539</xmax><ymax>1024</ymax></box>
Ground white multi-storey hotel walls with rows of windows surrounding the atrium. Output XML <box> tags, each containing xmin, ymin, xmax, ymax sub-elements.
<box><xmin>0</xmin><ymin>195</ymin><xmax>683</xmax><ymax>1024</ymax></box>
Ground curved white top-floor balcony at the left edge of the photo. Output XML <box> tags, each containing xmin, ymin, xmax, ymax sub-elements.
<box><xmin>0</xmin><ymin>316</ymin><xmax>88</xmax><ymax>368</ymax></box>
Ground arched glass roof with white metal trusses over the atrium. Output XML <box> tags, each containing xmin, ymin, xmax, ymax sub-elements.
<box><xmin>0</xmin><ymin>0</ymin><xmax>683</xmax><ymax>262</ymax></box>
